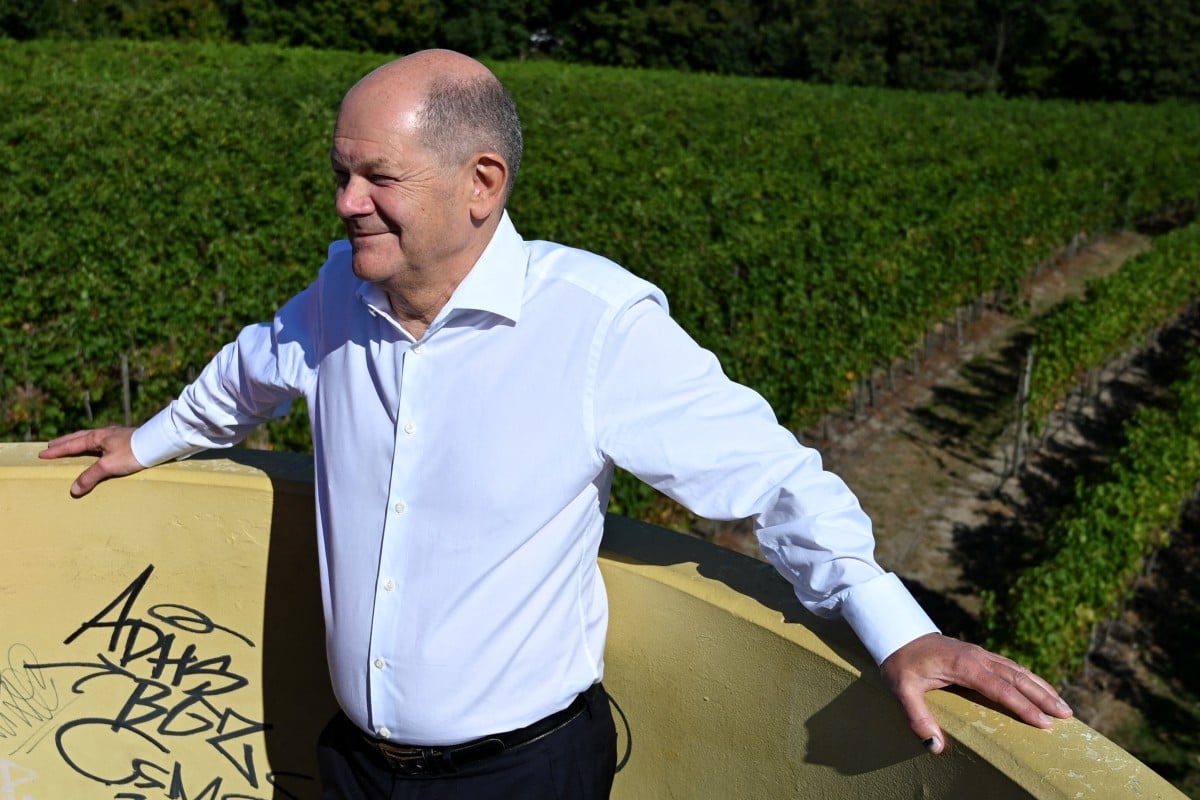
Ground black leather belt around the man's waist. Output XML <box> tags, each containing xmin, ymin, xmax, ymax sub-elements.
<box><xmin>362</xmin><ymin>684</ymin><xmax>600</xmax><ymax>775</ymax></box>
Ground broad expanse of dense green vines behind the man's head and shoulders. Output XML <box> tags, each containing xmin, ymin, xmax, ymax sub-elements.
<box><xmin>0</xmin><ymin>42</ymin><xmax>1200</xmax><ymax>513</ymax></box>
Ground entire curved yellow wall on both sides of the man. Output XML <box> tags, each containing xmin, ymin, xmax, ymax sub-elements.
<box><xmin>0</xmin><ymin>444</ymin><xmax>1183</xmax><ymax>800</ymax></box>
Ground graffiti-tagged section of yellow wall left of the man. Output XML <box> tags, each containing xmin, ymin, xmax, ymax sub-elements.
<box><xmin>0</xmin><ymin>445</ymin><xmax>335</xmax><ymax>800</ymax></box>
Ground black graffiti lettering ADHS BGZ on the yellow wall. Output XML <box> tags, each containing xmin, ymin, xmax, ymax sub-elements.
<box><xmin>0</xmin><ymin>565</ymin><xmax>313</xmax><ymax>800</ymax></box>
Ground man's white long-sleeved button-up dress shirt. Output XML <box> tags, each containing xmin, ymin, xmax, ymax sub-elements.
<box><xmin>133</xmin><ymin>215</ymin><xmax>936</xmax><ymax>745</ymax></box>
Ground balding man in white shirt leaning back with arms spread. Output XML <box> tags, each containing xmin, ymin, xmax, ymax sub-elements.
<box><xmin>43</xmin><ymin>50</ymin><xmax>1070</xmax><ymax>799</ymax></box>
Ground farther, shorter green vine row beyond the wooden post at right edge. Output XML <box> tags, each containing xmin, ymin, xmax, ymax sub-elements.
<box><xmin>1027</xmin><ymin>223</ymin><xmax>1200</xmax><ymax>432</ymax></box>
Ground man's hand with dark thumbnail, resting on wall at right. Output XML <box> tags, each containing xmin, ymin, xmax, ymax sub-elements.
<box><xmin>880</xmin><ymin>633</ymin><xmax>1072</xmax><ymax>753</ymax></box>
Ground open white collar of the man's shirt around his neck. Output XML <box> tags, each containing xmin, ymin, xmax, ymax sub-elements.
<box><xmin>358</xmin><ymin>211</ymin><xmax>529</xmax><ymax>332</ymax></box>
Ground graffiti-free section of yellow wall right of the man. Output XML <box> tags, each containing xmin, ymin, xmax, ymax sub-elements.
<box><xmin>601</xmin><ymin>519</ymin><xmax>1186</xmax><ymax>800</ymax></box>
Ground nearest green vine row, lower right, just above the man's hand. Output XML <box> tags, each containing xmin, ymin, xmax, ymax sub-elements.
<box><xmin>984</xmin><ymin>345</ymin><xmax>1200</xmax><ymax>680</ymax></box>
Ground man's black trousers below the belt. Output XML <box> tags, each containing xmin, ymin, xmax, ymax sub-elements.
<box><xmin>317</xmin><ymin>688</ymin><xmax>617</xmax><ymax>800</ymax></box>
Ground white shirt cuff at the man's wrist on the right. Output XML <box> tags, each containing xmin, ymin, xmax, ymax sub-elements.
<box><xmin>841</xmin><ymin>572</ymin><xmax>941</xmax><ymax>664</ymax></box>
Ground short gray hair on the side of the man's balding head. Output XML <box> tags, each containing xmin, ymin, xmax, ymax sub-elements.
<box><xmin>418</xmin><ymin>76</ymin><xmax>524</xmax><ymax>198</ymax></box>
